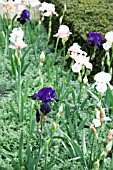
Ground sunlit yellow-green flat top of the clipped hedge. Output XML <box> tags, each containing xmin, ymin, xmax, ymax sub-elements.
<box><xmin>41</xmin><ymin>0</ymin><xmax>113</xmax><ymax>39</ymax></box>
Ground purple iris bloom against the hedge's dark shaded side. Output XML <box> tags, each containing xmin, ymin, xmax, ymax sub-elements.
<box><xmin>88</xmin><ymin>32</ymin><xmax>102</xmax><ymax>49</ymax></box>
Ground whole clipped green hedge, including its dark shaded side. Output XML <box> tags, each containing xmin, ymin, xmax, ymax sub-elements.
<box><xmin>41</xmin><ymin>0</ymin><xmax>113</xmax><ymax>76</ymax></box>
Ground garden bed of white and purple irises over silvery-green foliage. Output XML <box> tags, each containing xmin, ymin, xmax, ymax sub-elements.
<box><xmin>0</xmin><ymin>0</ymin><xmax>113</xmax><ymax>170</ymax></box>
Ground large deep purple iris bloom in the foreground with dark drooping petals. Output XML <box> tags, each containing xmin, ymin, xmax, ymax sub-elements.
<box><xmin>29</xmin><ymin>87</ymin><xmax>59</xmax><ymax>119</ymax></box>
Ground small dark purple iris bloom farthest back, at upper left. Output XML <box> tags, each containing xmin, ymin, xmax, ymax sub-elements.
<box><xmin>17</xmin><ymin>9</ymin><xmax>30</xmax><ymax>24</ymax></box>
